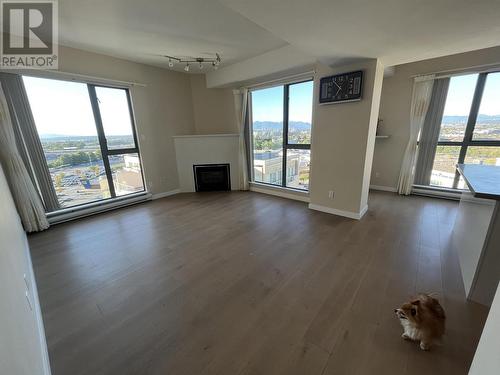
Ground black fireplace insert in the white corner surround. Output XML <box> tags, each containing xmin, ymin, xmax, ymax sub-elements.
<box><xmin>193</xmin><ymin>164</ymin><xmax>231</xmax><ymax>191</ymax></box>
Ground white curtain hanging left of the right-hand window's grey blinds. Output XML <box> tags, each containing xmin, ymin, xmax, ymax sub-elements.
<box><xmin>398</xmin><ymin>75</ymin><xmax>434</xmax><ymax>195</ymax></box>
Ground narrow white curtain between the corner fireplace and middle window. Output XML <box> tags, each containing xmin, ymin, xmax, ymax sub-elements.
<box><xmin>233</xmin><ymin>88</ymin><xmax>249</xmax><ymax>190</ymax></box>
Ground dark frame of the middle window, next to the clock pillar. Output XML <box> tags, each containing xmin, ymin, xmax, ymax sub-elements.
<box><xmin>248</xmin><ymin>78</ymin><xmax>314</xmax><ymax>193</ymax></box>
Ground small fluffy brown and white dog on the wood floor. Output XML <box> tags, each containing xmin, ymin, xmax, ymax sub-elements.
<box><xmin>394</xmin><ymin>294</ymin><xmax>446</xmax><ymax>350</ymax></box>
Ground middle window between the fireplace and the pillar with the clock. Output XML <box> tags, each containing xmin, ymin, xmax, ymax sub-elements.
<box><xmin>251</xmin><ymin>81</ymin><xmax>313</xmax><ymax>190</ymax></box>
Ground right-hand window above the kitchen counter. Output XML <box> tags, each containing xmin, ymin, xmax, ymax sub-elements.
<box><xmin>419</xmin><ymin>72</ymin><xmax>500</xmax><ymax>189</ymax></box>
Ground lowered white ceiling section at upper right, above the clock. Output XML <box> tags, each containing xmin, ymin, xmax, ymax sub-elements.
<box><xmin>221</xmin><ymin>0</ymin><xmax>500</xmax><ymax>65</ymax></box>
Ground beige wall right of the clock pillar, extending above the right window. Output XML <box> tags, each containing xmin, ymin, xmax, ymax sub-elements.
<box><xmin>371</xmin><ymin>47</ymin><xmax>500</xmax><ymax>188</ymax></box>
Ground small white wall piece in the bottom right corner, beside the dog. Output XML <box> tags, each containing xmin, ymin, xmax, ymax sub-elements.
<box><xmin>469</xmin><ymin>285</ymin><xmax>500</xmax><ymax>375</ymax></box>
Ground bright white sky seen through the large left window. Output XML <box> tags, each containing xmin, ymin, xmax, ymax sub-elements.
<box><xmin>23</xmin><ymin>76</ymin><xmax>132</xmax><ymax>136</ymax></box>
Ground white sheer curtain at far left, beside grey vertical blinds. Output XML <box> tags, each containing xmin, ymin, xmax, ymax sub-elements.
<box><xmin>0</xmin><ymin>85</ymin><xmax>49</xmax><ymax>232</ymax></box>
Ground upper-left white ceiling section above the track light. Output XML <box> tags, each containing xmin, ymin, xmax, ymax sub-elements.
<box><xmin>59</xmin><ymin>0</ymin><xmax>287</xmax><ymax>73</ymax></box>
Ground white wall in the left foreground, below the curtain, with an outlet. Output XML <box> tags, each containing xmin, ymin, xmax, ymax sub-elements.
<box><xmin>0</xmin><ymin>167</ymin><xmax>50</xmax><ymax>375</ymax></box>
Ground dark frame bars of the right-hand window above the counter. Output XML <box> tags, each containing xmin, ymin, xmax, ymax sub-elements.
<box><xmin>429</xmin><ymin>70</ymin><xmax>500</xmax><ymax>190</ymax></box>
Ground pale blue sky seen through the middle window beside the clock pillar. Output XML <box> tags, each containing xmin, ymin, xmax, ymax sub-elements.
<box><xmin>252</xmin><ymin>81</ymin><xmax>313</xmax><ymax>123</ymax></box>
